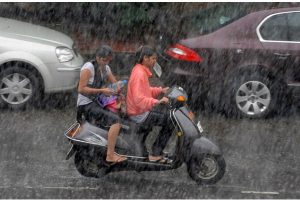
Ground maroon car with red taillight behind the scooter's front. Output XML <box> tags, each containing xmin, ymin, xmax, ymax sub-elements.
<box><xmin>162</xmin><ymin>7</ymin><xmax>300</xmax><ymax>118</ymax></box>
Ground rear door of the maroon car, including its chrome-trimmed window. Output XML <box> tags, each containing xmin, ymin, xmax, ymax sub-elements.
<box><xmin>257</xmin><ymin>11</ymin><xmax>300</xmax><ymax>84</ymax></box>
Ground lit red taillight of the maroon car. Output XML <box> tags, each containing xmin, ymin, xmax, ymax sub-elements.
<box><xmin>165</xmin><ymin>44</ymin><xmax>203</xmax><ymax>62</ymax></box>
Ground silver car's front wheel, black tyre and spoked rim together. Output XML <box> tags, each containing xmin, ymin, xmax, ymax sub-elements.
<box><xmin>0</xmin><ymin>66</ymin><xmax>41</xmax><ymax>109</ymax></box>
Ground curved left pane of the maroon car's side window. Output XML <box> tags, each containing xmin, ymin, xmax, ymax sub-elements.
<box><xmin>260</xmin><ymin>14</ymin><xmax>288</xmax><ymax>41</ymax></box>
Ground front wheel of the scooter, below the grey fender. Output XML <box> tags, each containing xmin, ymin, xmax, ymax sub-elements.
<box><xmin>188</xmin><ymin>154</ymin><xmax>226</xmax><ymax>185</ymax></box>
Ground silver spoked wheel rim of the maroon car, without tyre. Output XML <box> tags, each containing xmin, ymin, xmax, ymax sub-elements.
<box><xmin>235</xmin><ymin>81</ymin><xmax>271</xmax><ymax>116</ymax></box>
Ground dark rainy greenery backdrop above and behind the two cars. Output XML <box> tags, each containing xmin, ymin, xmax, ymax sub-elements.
<box><xmin>0</xmin><ymin>2</ymin><xmax>300</xmax><ymax>55</ymax></box>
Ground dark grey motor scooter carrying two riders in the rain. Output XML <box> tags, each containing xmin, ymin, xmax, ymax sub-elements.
<box><xmin>64</xmin><ymin>63</ymin><xmax>226</xmax><ymax>184</ymax></box>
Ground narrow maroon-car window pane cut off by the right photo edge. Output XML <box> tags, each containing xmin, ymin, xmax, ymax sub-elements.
<box><xmin>287</xmin><ymin>12</ymin><xmax>300</xmax><ymax>42</ymax></box>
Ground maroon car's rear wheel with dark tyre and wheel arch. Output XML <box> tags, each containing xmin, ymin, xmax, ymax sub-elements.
<box><xmin>223</xmin><ymin>70</ymin><xmax>285</xmax><ymax>118</ymax></box>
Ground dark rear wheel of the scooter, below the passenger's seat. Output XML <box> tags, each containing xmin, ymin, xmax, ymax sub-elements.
<box><xmin>74</xmin><ymin>152</ymin><xmax>106</xmax><ymax>178</ymax></box>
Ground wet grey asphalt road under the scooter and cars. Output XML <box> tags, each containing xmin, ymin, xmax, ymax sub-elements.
<box><xmin>0</xmin><ymin>97</ymin><xmax>300</xmax><ymax>198</ymax></box>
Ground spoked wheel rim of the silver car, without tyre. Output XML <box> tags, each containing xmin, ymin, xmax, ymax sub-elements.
<box><xmin>0</xmin><ymin>73</ymin><xmax>33</xmax><ymax>105</ymax></box>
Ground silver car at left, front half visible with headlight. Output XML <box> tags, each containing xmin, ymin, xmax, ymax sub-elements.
<box><xmin>0</xmin><ymin>18</ymin><xmax>83</xmax><ymax>109</ymax></box>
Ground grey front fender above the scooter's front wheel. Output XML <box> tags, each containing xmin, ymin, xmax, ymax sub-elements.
<box><xmin>188</xmin><ymin>136</ymin><xmax>222</xmax><ymax>160</ymax></box>
